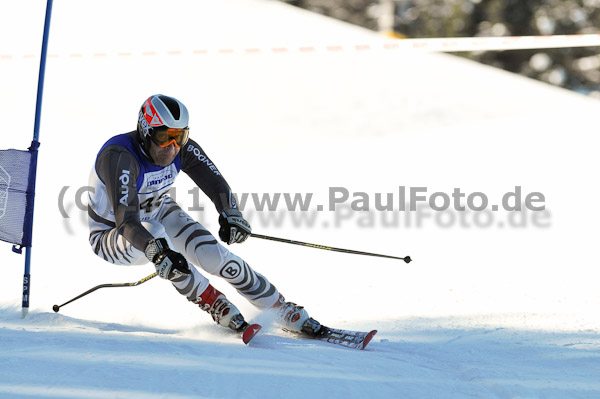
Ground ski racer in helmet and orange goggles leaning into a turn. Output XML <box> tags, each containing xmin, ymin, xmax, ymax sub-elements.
<box><xmin>88</xmin><ymin>94</ymin><xmax>320</xmax><ymax>335</ymax></box>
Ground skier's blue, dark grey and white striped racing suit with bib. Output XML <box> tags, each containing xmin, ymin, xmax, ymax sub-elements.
<box><xmin>88</xmin><ymin>131</ymin><xmax>279</xmax><ymax>309</ymax></box>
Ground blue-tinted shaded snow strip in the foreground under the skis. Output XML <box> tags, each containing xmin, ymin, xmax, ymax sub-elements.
<box><xmin>0</xmin><ymin>312</ymin><xmax>600</xmax><ymax>398</ymax></box>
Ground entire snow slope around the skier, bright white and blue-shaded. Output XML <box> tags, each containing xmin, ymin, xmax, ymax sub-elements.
<box><xmin>0</xmin><ymin>0</ymin><xmax>600</xmax><ymax>399</ymax></box>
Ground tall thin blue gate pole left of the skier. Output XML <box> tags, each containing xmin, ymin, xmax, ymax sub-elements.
<box><xmin>21</xmin><ymin>0</ymin><xmax>52</xmax><ymax>317</ymax></box>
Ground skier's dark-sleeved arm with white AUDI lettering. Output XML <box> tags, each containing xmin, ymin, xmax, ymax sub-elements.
<box><xmin>96</xmin><ymin>145</ymin><xmax>154</xmax><ymax>252</ymax></box>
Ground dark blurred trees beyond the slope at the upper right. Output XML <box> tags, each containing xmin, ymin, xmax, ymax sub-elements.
<box><xmin>283</xmin><ymin>0</ymin><xmax>600</xmax><ymax>98</ymax></box>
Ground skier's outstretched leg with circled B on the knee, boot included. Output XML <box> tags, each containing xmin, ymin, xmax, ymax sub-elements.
<box><xmin>159</xmin><ymin>199</ymin><xmax>318</xmax><ymax>331</ymax></box>
